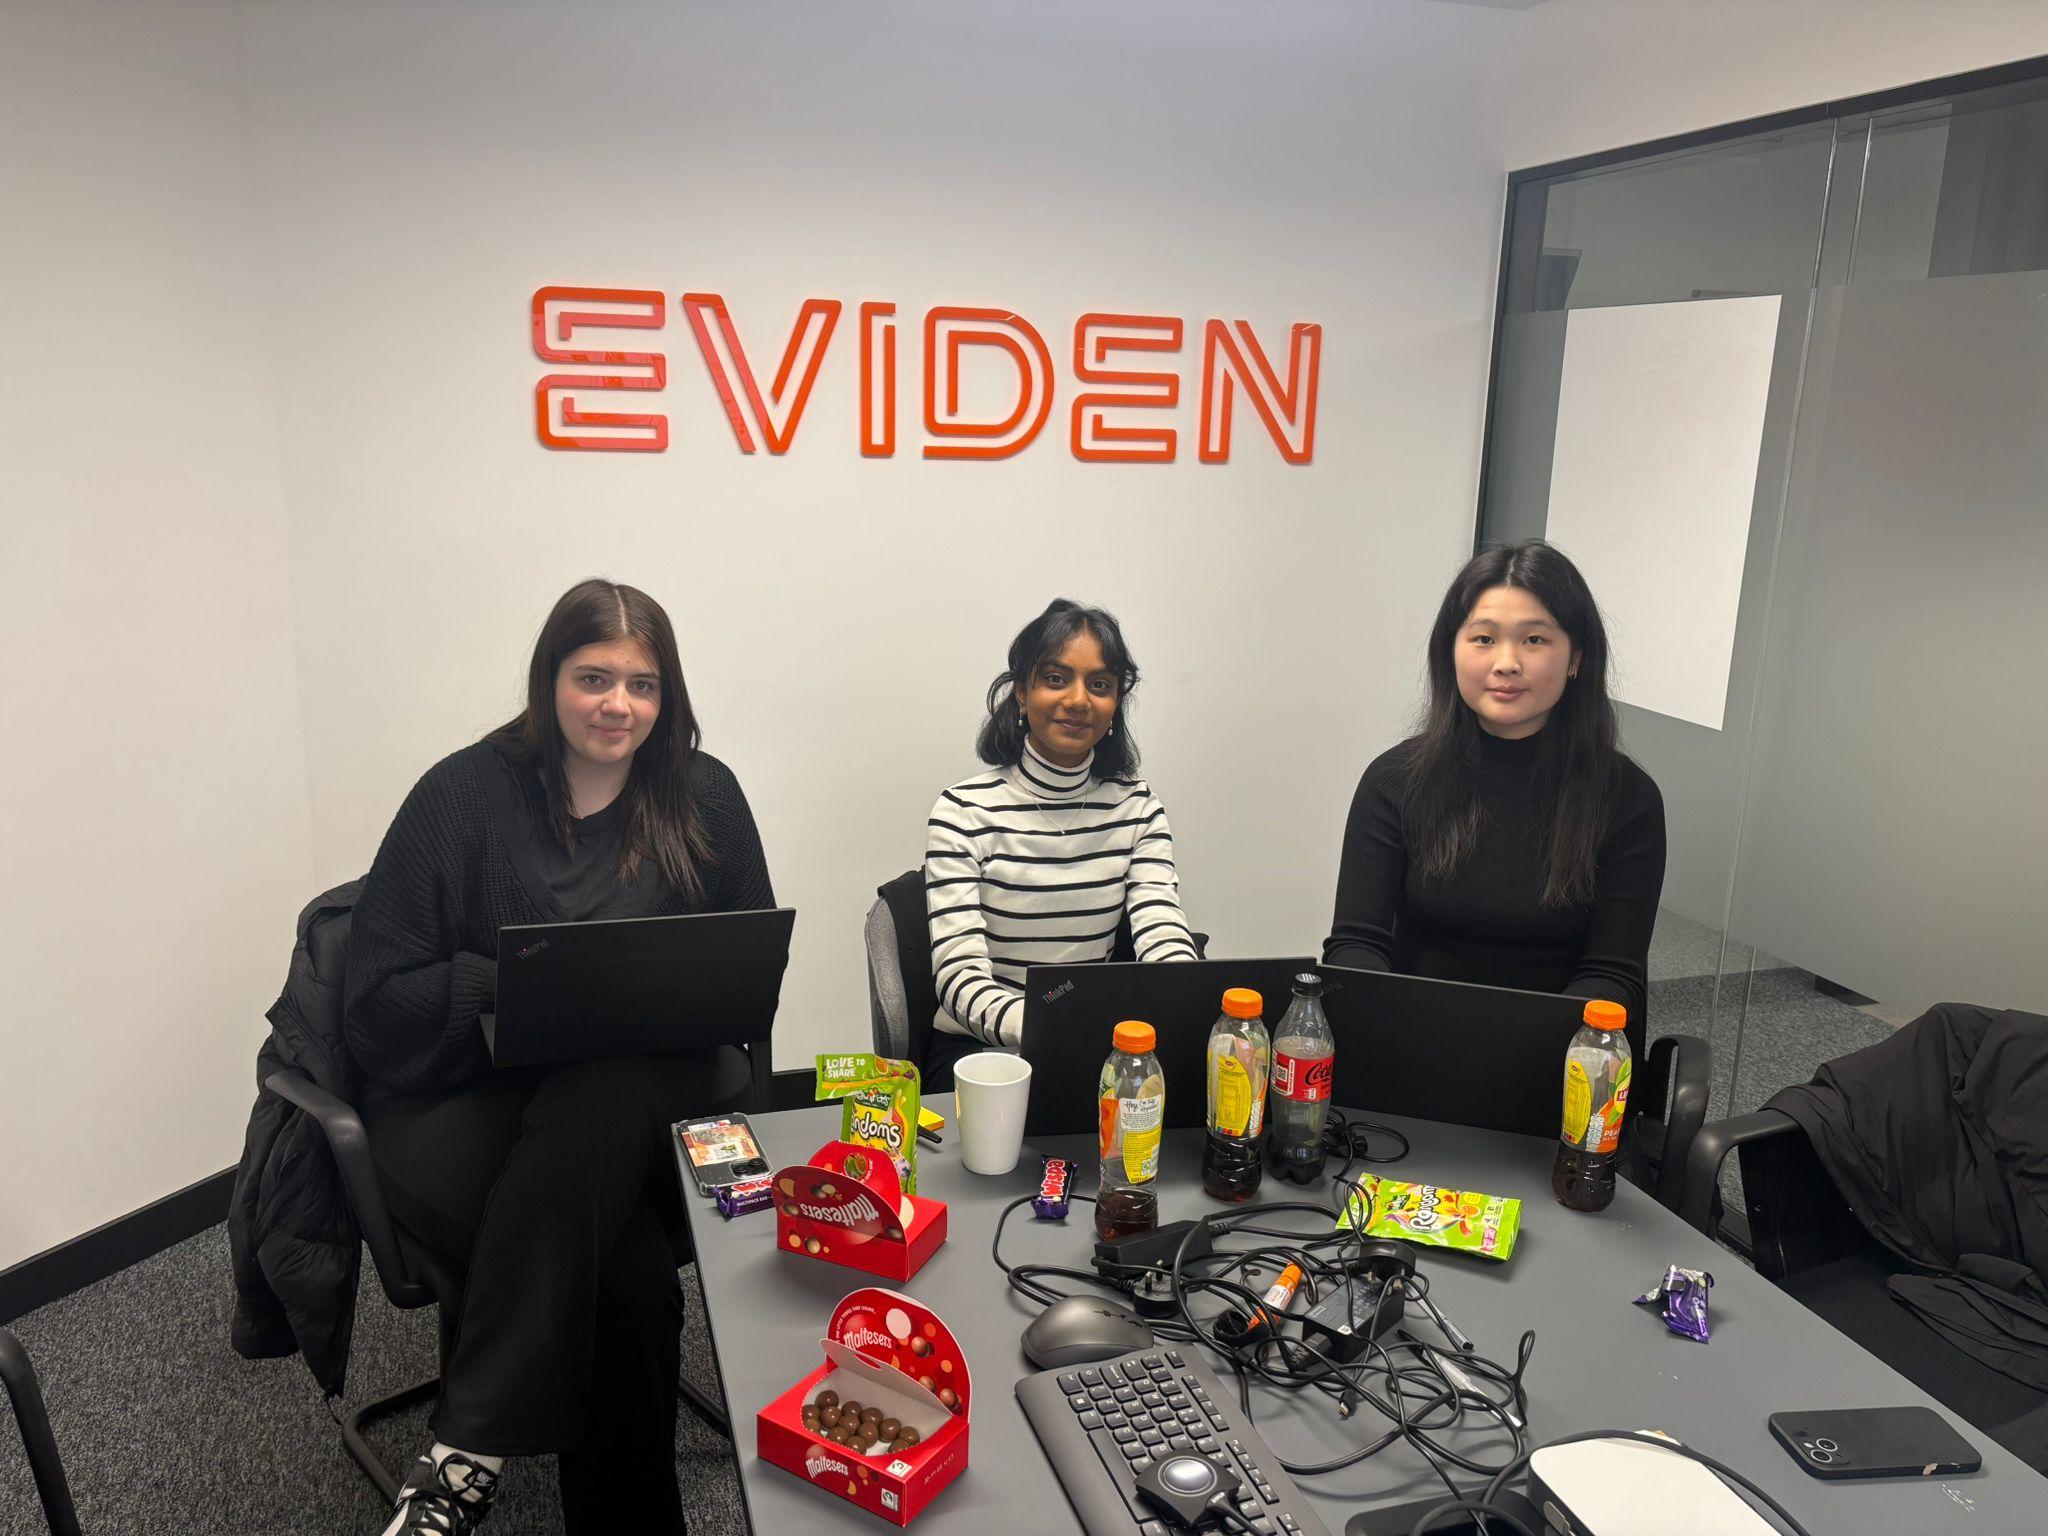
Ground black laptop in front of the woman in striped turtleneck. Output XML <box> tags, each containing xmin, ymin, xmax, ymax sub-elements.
<box><xmin>1024</xmin><ymin>956</ymin><xmax>1310</xmax><ymax>1137</ymax></box>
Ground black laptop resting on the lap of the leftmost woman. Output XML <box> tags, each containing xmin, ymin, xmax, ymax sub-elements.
<box><xmin>483</xmin><ymin>907</ymin><xmax>797</xmax><ymax>1067</ymax></box>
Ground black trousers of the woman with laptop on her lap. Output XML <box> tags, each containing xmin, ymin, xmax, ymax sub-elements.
<box><xmin>365</xmin><ymin>1051</ymin><xmax>745</xmax><ymax>1536</ymax></box>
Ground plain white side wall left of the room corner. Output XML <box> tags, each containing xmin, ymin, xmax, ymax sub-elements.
<box><xmin>0</xmin><ymin>4</ymin><xmax>313</xmax><ymax>1266</ymax></box>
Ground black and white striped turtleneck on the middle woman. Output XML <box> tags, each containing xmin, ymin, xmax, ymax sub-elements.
<box><xmin>924</xmin><ymin>739</ymin><xmax>1196</xmax><ymax>1047</ymax></box>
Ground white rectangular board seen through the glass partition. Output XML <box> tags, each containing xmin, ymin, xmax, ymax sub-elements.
<box><xmin>1546</xmin><ymin>303</ymin><xmax>1780</xmax><ymax>731</ymax></box>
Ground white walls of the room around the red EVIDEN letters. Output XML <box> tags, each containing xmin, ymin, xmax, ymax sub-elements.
<box><xmin>0</xmin><ymin>0</ymin><xmax>2048</xmax><ymax>1264</ymax></box>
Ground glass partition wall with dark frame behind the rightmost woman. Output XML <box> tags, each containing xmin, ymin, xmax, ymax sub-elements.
<box><xmin>1479</xmin><ymin>54</ymin><xmax>2048</xmax><ymax>1179</ymax></box>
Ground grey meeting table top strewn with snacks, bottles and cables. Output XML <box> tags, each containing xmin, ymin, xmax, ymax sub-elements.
<box><xmin>686</xmin><ymin>1094</ymin><xmax>2048</xmax><ymax>1536</ymax></box>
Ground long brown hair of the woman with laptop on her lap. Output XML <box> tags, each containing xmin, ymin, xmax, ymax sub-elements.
<box><xmin>492</xmin><ymin>578</ymin><xmax>711</xmax><ymax>901</ymax></box>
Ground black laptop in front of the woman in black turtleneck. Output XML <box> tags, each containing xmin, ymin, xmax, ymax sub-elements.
<box><xmin>1318</xmin><ymin>965</ymin><xmax>1585</xmax><ymax>1137</ymax></box>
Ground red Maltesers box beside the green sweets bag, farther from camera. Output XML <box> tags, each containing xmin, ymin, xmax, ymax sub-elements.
<box><xmin>774</xmin><ymin>1141</ymin><xmax>946</xmax><ymax>1280</ymax></box>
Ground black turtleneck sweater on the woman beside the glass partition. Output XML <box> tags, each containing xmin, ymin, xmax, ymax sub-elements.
<box><xmin>1323</xmin><ymin>733</ymin><xmax>1665</xmax><ymax>1024</ymax></box>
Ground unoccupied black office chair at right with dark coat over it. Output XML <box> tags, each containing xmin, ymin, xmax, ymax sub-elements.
<box><xmin>1679</xmin><ymin>1110</ymin><xmax>2048</xmax><ymax>1454</ymax></box>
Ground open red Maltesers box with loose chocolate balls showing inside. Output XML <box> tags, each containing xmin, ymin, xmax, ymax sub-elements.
<box><xmin>754</xmin><ymin>1286</ymin><xmax>973</xmax><ymax>1526</ymax></box>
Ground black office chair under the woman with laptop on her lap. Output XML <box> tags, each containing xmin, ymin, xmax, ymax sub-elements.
<box><xmin>264</xmin><ymin>1036</ymin><xmax>772</xmax><ymax>1499</ymax></box>
